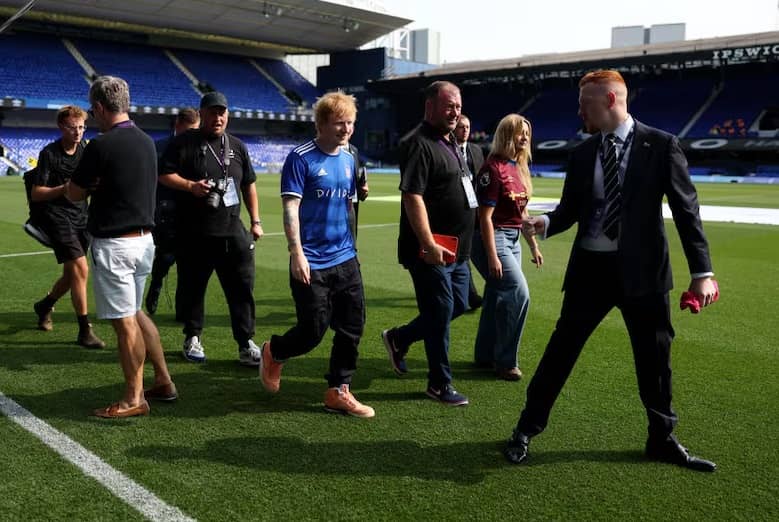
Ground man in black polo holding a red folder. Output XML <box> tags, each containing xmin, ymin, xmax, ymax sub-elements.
<box><xmin>381</xmin><ymin>81</ymin><xmax>477</xmax><ymax>406</ymax></box>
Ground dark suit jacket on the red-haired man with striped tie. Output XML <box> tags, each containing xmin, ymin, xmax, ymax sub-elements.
<box><xmin>547</xmin><ymin>121</ymin><xmax>712</xmax><ymax>297</ymax></box>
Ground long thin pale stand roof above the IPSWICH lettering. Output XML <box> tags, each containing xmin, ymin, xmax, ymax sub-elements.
<box><xmin>386</xmin><ymin>31</ymin><xmax>779</xmax><ymax>80</ymax></box>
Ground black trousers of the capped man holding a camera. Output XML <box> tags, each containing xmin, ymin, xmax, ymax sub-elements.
<box><xmin>176</xmin><ymin>233</ymin><xmax>254</xmax><ymax>346</ymax></box>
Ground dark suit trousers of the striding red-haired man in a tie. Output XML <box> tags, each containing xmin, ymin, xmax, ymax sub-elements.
<box><xmin>517</xmin><ymin>250</ymin><xmax>677</xmax><ymax>440</ymax></box>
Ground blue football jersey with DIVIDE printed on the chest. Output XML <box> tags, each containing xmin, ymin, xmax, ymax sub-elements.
<box><xmin>281</xmin><ymin>140</ymin><xmax>356</xmax><ymax>270</ymax></box>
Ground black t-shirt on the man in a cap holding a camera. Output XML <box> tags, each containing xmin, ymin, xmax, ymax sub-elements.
<box><xmin>160</xmin><ymin>129</ymin><xmax>257</xmax><ymax>237</ymax></box>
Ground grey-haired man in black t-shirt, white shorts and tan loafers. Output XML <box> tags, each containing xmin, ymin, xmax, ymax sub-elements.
<box><xmin>66</xmin><ymin>76</ymin><xmax>178</xmax><ymax>418</ymax></box>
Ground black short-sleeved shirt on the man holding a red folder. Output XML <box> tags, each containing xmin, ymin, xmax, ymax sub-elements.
<box><xmin>398</xmin><ymin>122</ymin><xmax>475</xmax><ymax>266</ymax></box>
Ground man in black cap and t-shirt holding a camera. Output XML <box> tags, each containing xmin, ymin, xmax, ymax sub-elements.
<box><xmin>160</xmin><ymin>92</ymin><xmax>263</xmax><ymax>366</ymax></box>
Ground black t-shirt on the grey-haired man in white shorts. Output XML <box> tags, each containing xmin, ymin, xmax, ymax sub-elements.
<box><xmin>72</xmin><ymin>120</ymin><xmax>157</xmax><ymax>237</ymax></box>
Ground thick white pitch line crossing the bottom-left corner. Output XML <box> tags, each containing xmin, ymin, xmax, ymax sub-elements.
<box><xmin>0</xmin><ymin>392</ymin><xmax>195</xmax><ymax>522</ymax></box>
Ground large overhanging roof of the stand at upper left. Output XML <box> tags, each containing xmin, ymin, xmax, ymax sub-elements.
<box><xmin>0</xmin><ymin>0</ymin><xmax>411</xmax><ymax>53</ymax></box>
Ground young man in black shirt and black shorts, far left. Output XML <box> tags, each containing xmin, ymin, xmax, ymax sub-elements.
<box><xmin>30</xmin><ymin>105</ymin><xmax>105</xmax><ymax>348</ymax></box>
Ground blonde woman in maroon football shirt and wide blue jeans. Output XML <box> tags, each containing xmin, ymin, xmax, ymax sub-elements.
<box><xmin>472</xmin><ymin>114</ymin><xmax>544</xmax><ymax>381</ymax></box>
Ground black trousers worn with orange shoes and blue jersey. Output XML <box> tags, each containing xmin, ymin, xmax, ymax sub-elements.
<box><xmin>271</xmin><ymin>258</ymin><xmax>365</xmax><ymax>387</ymax></box>
